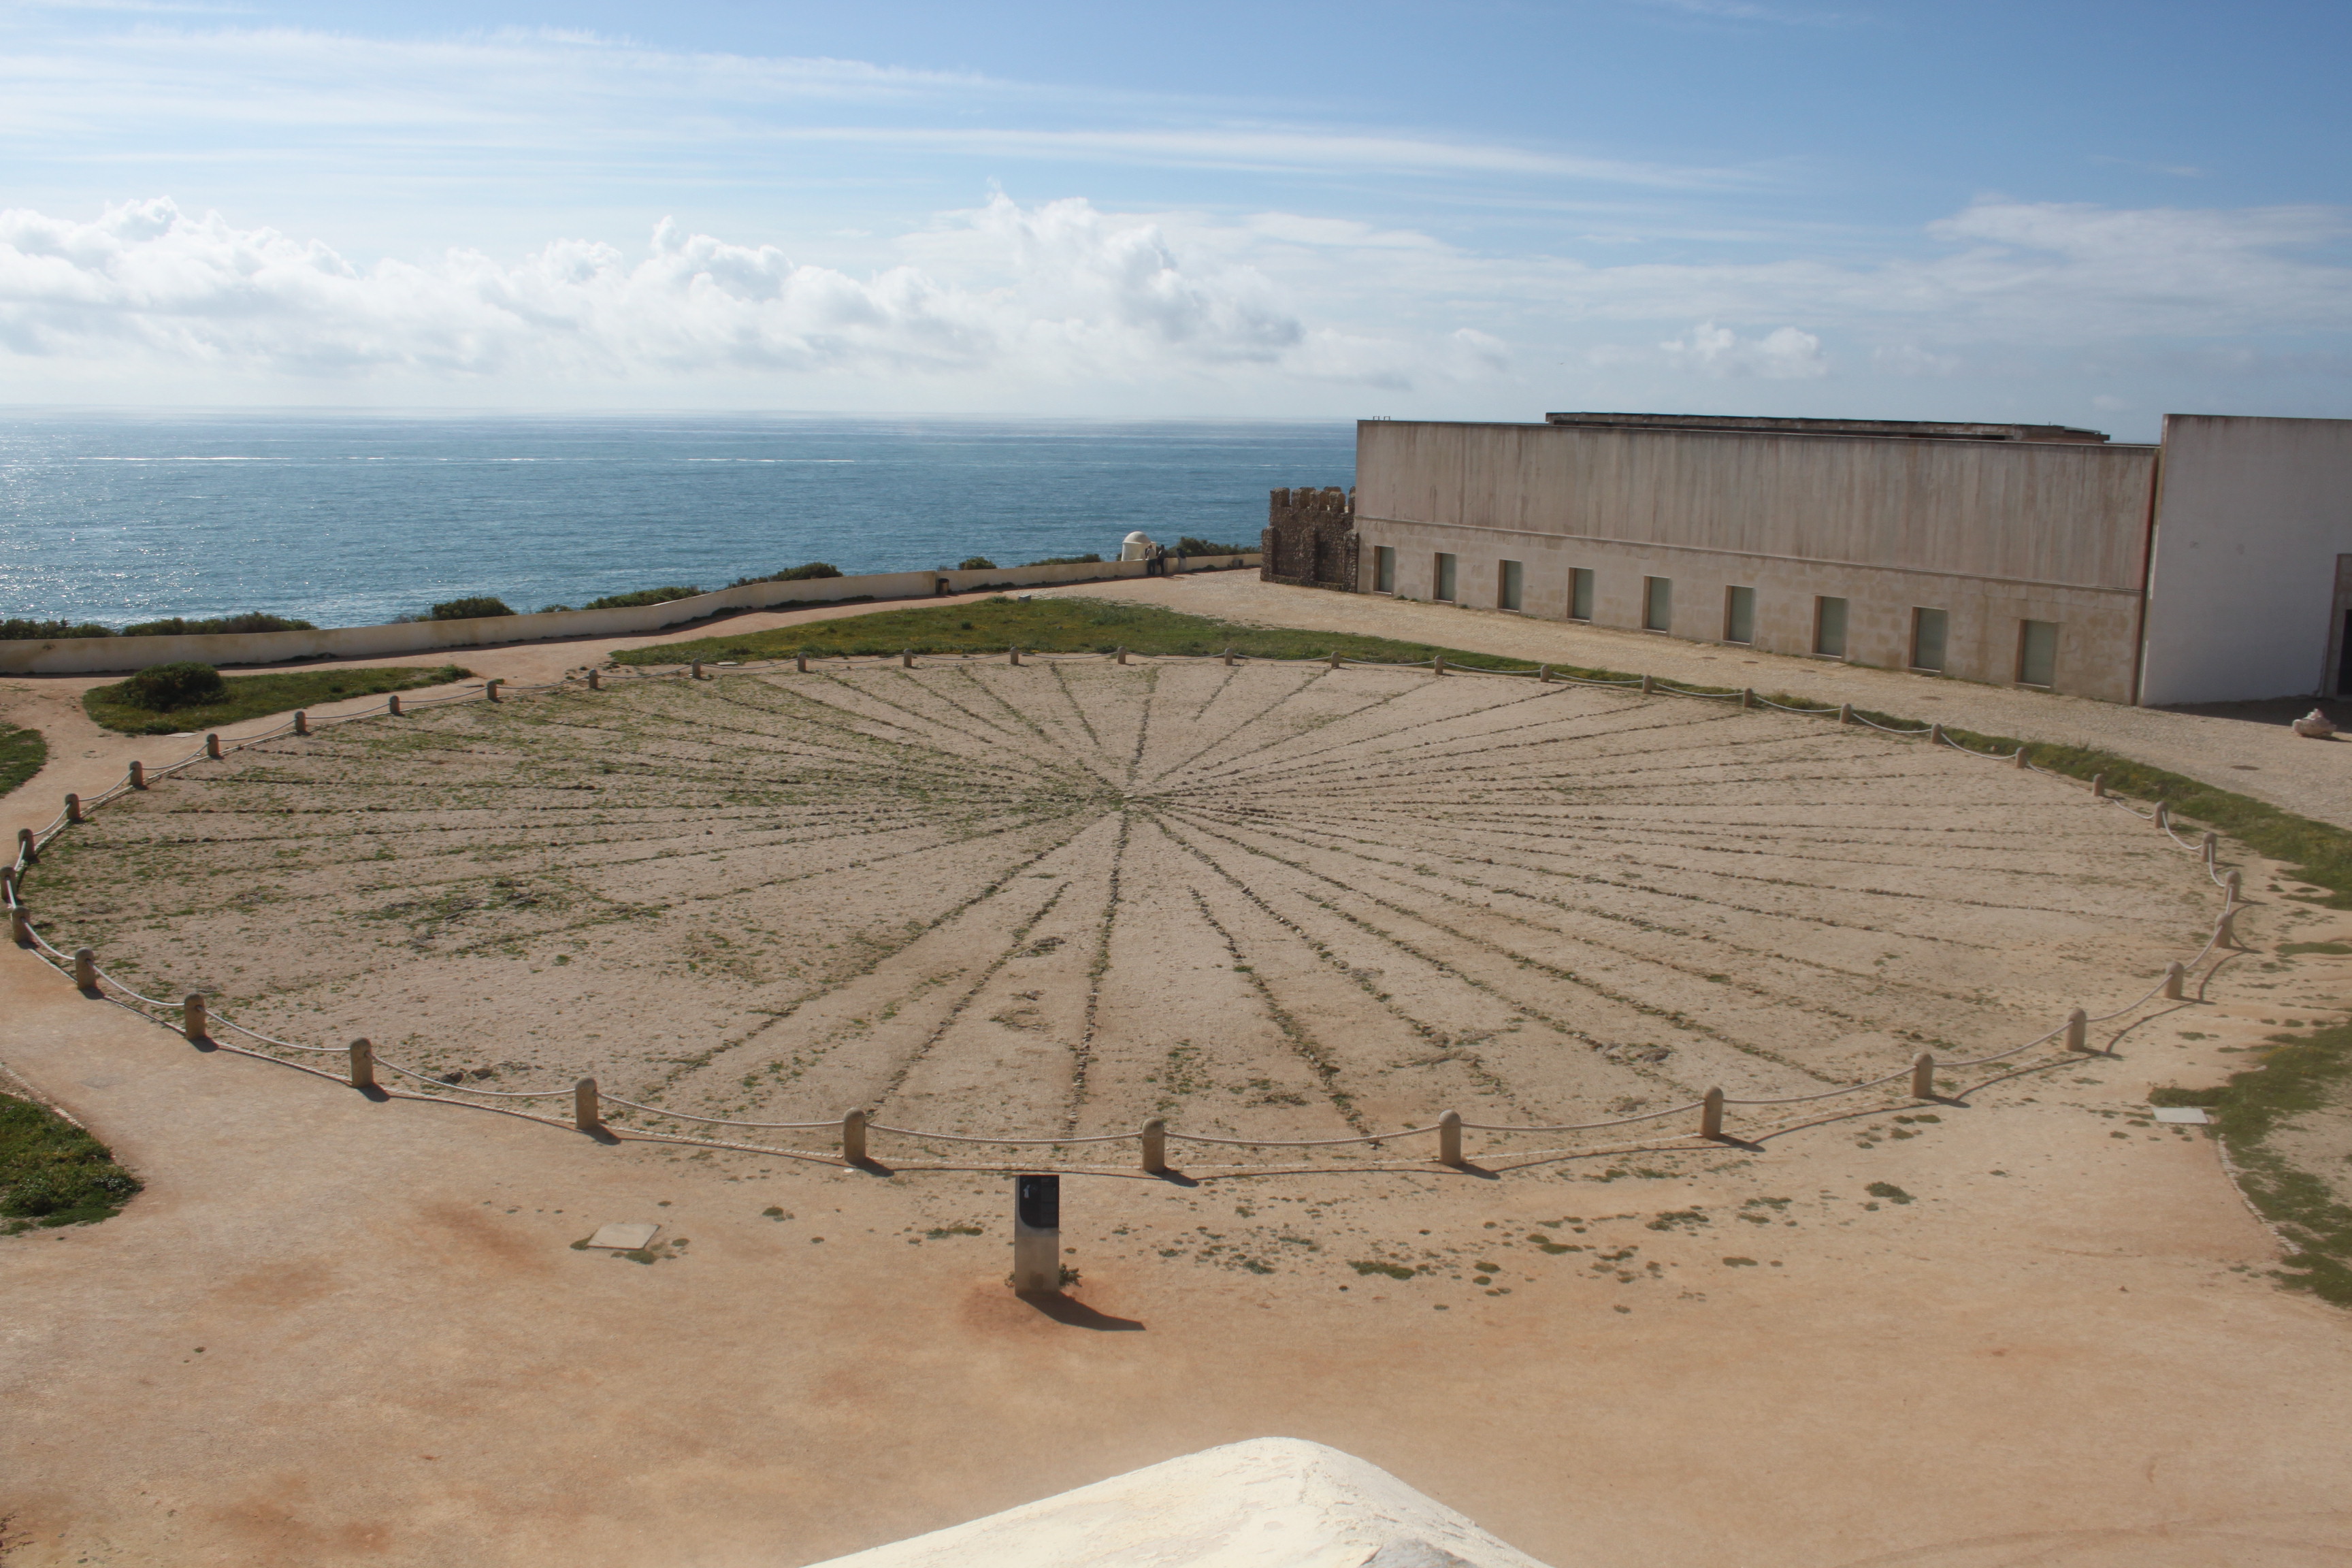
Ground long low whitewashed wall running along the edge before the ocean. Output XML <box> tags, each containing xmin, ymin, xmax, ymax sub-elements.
<box><xmin>0</xmin><ymin>550</ymin><xmax>1258</xmax><ymax>674</ymax></box>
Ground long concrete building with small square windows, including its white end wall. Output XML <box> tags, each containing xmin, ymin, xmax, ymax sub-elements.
<box><xmin>1265</xmin><ymin>414</ymin><xmax>2352</xmax><ymax>703</ymax></box>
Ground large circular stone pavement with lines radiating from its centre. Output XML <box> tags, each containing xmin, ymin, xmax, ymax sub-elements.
<box><xmin>28</xmin><ymin>661</ymin><xmax>2216</xmax><ymax>1147</ymax></box>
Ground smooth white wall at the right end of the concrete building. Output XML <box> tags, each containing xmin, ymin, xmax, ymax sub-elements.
<box><xmin>2140</xmin><ymin>414</ymin><xmax>2352</xmax><ymax>705</ymax></box>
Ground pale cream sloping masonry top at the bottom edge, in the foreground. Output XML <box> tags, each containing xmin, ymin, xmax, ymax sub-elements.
<box><xmin>819</xmin><ymin>1437</ymin><xmax>1543</xmax><ymax>1568</ymax></box>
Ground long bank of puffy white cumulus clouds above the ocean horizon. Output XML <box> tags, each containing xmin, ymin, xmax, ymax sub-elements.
<box><xmin>0</xmin><ymin>195</ymin><xmax>1501</xmax><ymax>390</ymax></box>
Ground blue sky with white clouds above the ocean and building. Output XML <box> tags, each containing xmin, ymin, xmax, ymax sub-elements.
<box><xmin>0</xmin><ymin>0</ymin><xmax>2352</xmax><ymax>440</ymax></box>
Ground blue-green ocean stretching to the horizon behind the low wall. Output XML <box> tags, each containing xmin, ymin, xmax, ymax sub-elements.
<box><xmin>0</xmin><ymin>411</ymin><xmax>1355</xmax><ymax>625</ymax></box>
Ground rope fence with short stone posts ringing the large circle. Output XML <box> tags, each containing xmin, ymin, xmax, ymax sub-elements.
<box><xmin>0</xmin><ymin>649</ymin><xmax>2244</xmax><ymax>1175</ymax></box>
